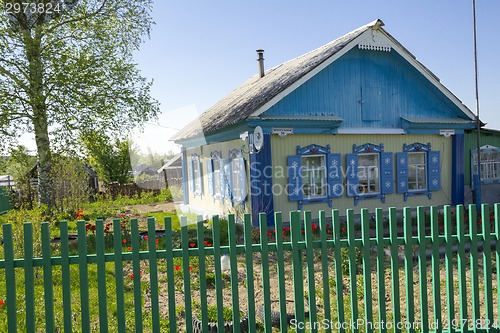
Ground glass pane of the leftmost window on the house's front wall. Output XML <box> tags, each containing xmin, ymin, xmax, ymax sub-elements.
<box><xmin>302</xmin><ymin>155</ymin><xmax>327</xmax><ymax>199</ymax></box>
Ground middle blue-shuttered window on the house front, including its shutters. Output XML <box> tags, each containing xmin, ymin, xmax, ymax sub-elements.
<box><xmin>346</xmin><ymin>143</ymin><xmax>394</xmax><ymax>205</ymax></box>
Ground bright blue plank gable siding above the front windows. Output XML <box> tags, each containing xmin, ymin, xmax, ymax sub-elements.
<box><xmin>265</xmin><ymin>48</ymin><xmax>463</xmax><ymax>127</ymax></box>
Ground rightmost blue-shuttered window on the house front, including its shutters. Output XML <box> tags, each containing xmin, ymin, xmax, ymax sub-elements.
<box><xmin>396</xmin><ymin>142</ymin><xmax>441</xmax><ymax>201</ymax></box>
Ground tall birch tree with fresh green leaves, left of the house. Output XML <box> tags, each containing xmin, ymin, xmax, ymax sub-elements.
<box><xmin>0</xmin><ymin>0</ymin><xmax>158</xmax><ymax>208</ymax></box>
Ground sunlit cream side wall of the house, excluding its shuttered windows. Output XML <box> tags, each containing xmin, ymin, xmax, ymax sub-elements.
<box><xmin>184</xmin><ymin>139</ymin><xmax>250</xmax><ymax>216</ymax></box>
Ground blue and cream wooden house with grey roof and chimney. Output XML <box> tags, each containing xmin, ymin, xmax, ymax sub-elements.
<box><xmin>174</xmin><ymin>20</ymin><xmax>475</xmax><ymax>223</ymax></box>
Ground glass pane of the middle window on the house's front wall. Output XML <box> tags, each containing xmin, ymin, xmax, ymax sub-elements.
<box><xmin>358</xmin><ymin>153</ymin><xmax>380</xmax><ymax>195</ymax></box>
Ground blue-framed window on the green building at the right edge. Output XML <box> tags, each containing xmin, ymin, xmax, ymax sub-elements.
<box><xmin>471</xmin><ymin>145</ymin><xmax>500</xmax><ymax>184</ymax></box>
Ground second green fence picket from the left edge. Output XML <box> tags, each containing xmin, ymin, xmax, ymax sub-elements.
<box><xmin>23</xmin><ymin>223</ymin><xmax>35</xmax><ymax>332</ymax></box>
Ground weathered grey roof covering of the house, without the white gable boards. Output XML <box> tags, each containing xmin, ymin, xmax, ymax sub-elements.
<box><xmin>172</xmin><ymin>20</ymin><xmax>476</xmax><ymax>142</ymax></box>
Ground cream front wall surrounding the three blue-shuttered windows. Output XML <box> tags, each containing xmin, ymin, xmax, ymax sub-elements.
<box><xmin>271</xmin><ymin>134</ymin><xmax>452</xmax><ymax>217</ymax></box>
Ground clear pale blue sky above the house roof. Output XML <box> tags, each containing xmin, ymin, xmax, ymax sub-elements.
<box><xmin>135</xmin><ymin>0</ymin><xmax>500</xmax><ymax>151</ymax></box>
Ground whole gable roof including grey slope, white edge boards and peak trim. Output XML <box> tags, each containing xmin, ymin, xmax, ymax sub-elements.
<box><xmin>172</xmin><ymin>20</ymin><xmax>475</xmax><ymax>141</ymax></box>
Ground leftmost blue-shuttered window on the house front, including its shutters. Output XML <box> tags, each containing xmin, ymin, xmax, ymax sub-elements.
<box><xmin>286</xmin><ymin>145</ymin><xmax>343</xmax><ymax>209</ymax></box>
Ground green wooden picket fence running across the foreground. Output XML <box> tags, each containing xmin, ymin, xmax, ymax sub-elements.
<box><xmin>0</xmin><ymin>204</ymin><xmax>500</xmax><ymax>333</ymax></box>
